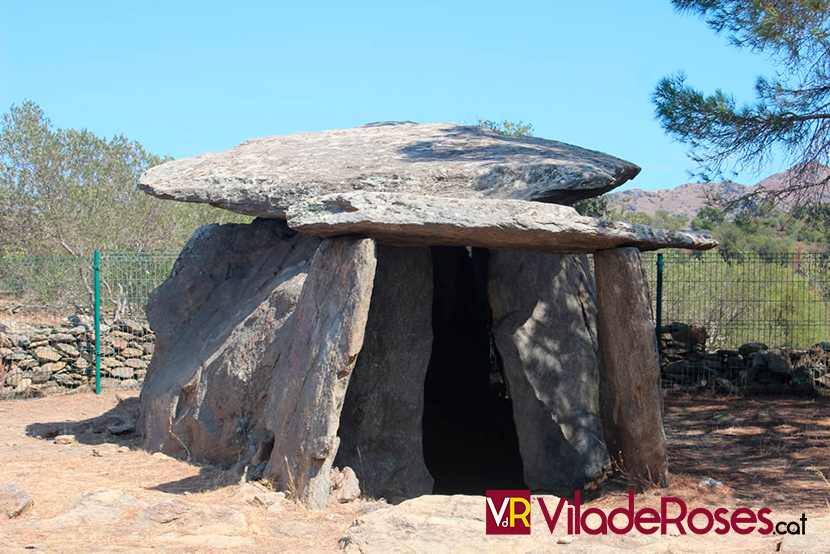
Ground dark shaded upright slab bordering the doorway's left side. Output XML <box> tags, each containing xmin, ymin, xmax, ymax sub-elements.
<box><xmin>335</xmin><ymin>245</ymin><xmax>433</xmax><ymax>498</ymax></box>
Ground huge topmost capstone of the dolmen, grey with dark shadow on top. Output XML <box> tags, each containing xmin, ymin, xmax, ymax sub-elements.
<box><xmin>139</xmin><ymin>122</ymin><xmax>640</xmax><ymax>218</ymax></box>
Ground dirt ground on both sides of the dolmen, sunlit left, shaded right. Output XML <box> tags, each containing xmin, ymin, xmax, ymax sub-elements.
<box><xmin>0</xmin><ymin>392</ymin><xmax>830</xmax><ymax>552</ymax></box>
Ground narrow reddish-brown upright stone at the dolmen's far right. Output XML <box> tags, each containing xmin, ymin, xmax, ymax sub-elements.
<box><xmin>594</xmin><ymin>248</ymin><xmax>668</xmax><ymax>488</ymax></box>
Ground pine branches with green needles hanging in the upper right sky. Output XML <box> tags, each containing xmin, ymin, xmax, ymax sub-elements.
<box><xmin>652</xmin><ymin>0</ymin><xmax>830</xmax><ymax>203</ymax></box>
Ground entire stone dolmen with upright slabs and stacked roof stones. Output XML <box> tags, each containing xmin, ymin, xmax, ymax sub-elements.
<box><xmin>139</xmin><ymin>122</ymin><xmax>716</xmax><ymax>509</ymax></box>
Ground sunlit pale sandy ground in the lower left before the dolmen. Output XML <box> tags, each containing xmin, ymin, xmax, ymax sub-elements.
<box><xmin>0</xmin><ymin>392</ymin><xmax>374</xmax><ymax>552</ymax></box>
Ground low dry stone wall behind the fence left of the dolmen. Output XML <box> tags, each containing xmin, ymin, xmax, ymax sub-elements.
<box><xmin>0</xmin><ymin>314</ymin><xmax>155</xmax><ymax>398</ymax></box>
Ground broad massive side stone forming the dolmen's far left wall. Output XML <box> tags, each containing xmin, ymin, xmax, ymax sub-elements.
<box><xmin>141</xmin><ymin>220</ymin><xmax>320</xmax><ymax>465</ymax></box>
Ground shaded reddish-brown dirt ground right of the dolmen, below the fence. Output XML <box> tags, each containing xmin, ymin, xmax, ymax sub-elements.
<box><xmin>665</xmin><ymin>396</ymin><xmax>830</xmax><ymax>512</ymax></box>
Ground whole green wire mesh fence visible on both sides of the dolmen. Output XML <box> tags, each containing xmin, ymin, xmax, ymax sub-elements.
<box><xmin>0</xmin><ymin>250</ymin><xmax>830</xmax><ymax>398</ymax></box>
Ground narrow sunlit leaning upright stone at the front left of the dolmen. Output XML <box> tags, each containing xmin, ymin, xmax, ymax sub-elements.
<box><xmin>265</xmin><ymin>238</ymin><xmax>376</xmax><ymax>510</ymax></box>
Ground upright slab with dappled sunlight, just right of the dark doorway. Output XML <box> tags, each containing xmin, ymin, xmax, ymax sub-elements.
<box><xmin>488</xmin><ymin>250</ymin><xmax>608</xmax><ymax>495</ymax></box>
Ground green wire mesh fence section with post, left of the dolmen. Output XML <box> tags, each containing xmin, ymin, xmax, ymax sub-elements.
<box><xmin>0</xmin><ymin>252</ymin><xmax>177</xmax><ymax>398</ymax></box>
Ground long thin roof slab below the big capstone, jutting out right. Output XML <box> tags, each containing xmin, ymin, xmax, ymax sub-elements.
<box><xmin>288</xmin><ymin>192</ymin><xmax>718</xmax><ymax>253</ymax></box>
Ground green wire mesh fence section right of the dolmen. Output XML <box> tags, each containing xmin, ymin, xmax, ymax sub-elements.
<box><xmin>643</xmin><ymin>250</ymin><xmax>830</xmax><ymax>393</ymax></box>
